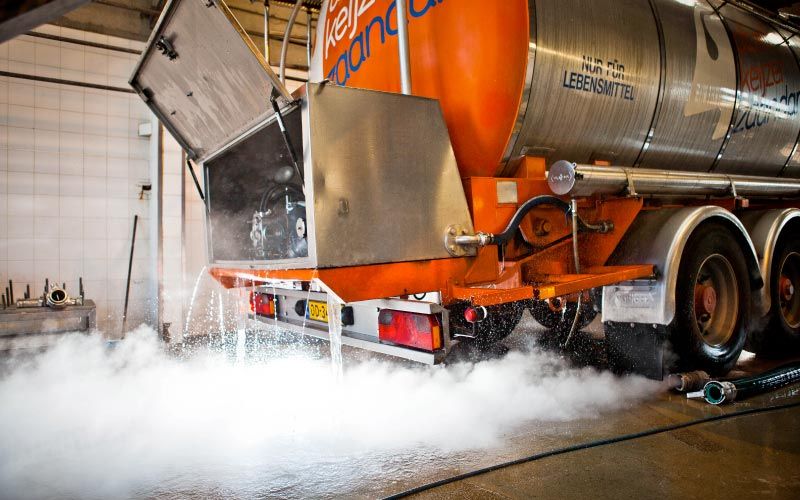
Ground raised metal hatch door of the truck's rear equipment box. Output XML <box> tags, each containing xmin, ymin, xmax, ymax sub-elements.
<box><xmin>130</xmin><ymin>0</ymin><xmax>291</xmax><ymax>160</ymax></box>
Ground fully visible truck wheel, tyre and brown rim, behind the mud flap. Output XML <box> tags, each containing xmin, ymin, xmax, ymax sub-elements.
<box><xmin>669</xmin><ymin>224</ymin><xmax>750</xmax><ymax>375</ymax></box>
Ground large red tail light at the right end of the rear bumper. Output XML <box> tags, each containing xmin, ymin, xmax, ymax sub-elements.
<box><xmin>378</xmin><ymin>309</ymin><xmax>442</xmax><ymax>351</ymax></box>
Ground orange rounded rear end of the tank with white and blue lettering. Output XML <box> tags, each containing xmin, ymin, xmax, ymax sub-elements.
<box><xmin>315</xmin><ymin>0</ymin><xmax>529</xmax><ymax>177</ymax></box>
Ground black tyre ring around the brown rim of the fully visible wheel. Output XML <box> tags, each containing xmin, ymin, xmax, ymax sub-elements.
<box><xmin>668</xmin><ymin>223</ymin><xmax>750</xmax><ymax>375</ymax></box>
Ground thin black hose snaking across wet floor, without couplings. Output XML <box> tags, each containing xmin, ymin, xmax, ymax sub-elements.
<box><xmin>384</xmin><ymin>401</ymin><xmax>800</xmax><ymax>500</ymax></box>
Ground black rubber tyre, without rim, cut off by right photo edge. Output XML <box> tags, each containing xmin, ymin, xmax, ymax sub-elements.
<box><xmin>748</xmin><ymin>235</ymin><xmax>800</xmax><ymax>358</ymax></box>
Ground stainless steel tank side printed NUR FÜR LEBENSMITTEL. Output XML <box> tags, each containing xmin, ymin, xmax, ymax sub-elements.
<box><xmin>512</xmin><ymin>0</ymin><xmax>800</xmax><ymax>176</ymax></box>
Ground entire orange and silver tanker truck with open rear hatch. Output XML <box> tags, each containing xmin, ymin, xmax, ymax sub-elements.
<box><xmin>130</xmin><ymin>0</ymin><xmax>800</xmax><ymax>377</ymax></box>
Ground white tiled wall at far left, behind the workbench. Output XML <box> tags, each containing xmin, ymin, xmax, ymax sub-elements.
<box><xmin>0</xmin><ymin>26</ymin><xmax>154</xmax><ymax>336</ymax></box>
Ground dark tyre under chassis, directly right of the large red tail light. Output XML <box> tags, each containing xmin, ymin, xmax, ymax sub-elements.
<box><xmin>448</xmin><ymin>302</ymin><xmax>525</xmax><ymax>349</ymax></box>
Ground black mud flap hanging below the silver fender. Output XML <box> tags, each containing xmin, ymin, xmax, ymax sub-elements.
<box><xmin>603</xmin><ymin>321</ymin><xmax>667</xmax><ymax>380</ymax></box>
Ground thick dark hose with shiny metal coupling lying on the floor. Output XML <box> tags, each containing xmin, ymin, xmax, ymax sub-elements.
<box><xmin>703</xmin><ymin>361</ymin><xmax>800</xmax><ymax>405</ymax></box>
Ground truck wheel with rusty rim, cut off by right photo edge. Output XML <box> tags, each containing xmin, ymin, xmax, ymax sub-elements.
<box><xmin>750</xmin><ymin>241</ymin><xmax>800</xmax><ymax>357</ymax></box>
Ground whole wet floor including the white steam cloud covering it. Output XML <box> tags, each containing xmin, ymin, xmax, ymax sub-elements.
<box><xmin>0</xmin><ymin>323</ymin><xmax>800</xmax><ymax>499</ymax></box>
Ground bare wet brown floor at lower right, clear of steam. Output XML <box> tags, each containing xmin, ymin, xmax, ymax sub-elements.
<box><xmin>382</xmin><ymin>350</ymin><xmax>800</xmax><ymax>499</ymax></box>
